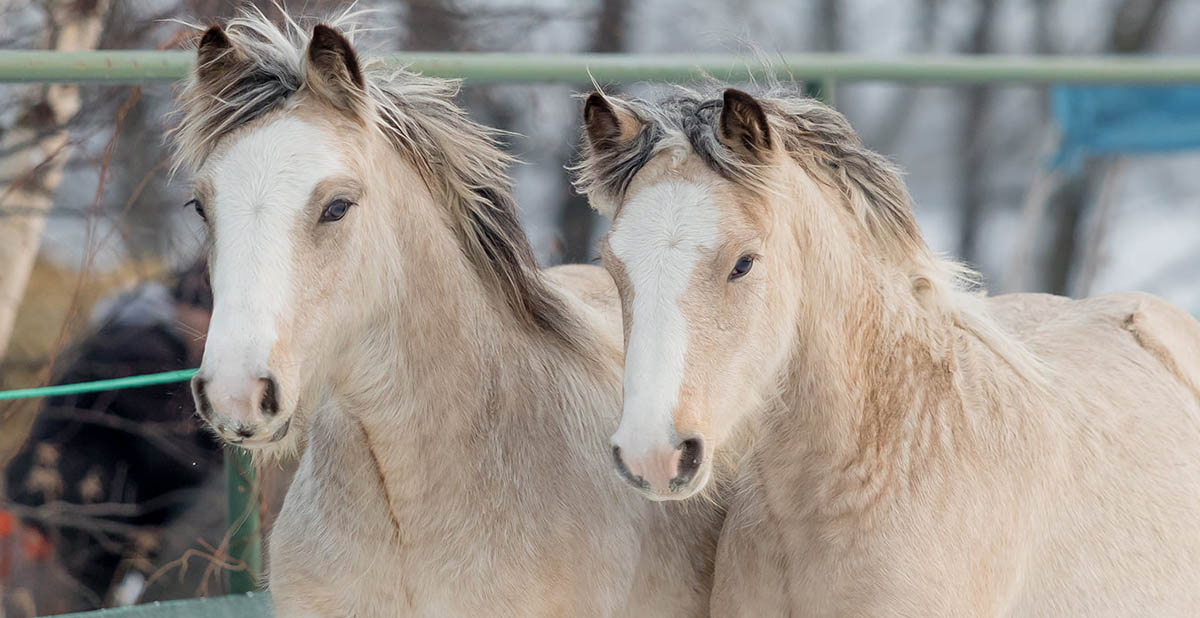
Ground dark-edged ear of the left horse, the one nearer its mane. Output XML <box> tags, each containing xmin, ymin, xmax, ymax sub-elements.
<box><xmin>305</xmin><ymin>24</ymin><xmax>366</xmax><ymax>113</ymax></box>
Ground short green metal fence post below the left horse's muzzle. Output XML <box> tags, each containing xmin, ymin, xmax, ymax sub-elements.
<box><xmin>224</xmin><ymin>446</ymin><xmax>263</xmax><ymax>594</ymax></box>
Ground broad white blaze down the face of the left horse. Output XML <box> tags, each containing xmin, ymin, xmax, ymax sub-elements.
<box><xmin>202</xmin><ymin>118</ymin><xmax>344</xmax><ymax>410</ymax></box>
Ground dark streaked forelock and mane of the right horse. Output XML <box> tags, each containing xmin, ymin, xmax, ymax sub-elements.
<box><xmin>572</xmin><ymin>84</ymin><xmax>924</xmax><ymax>259</ymax></box>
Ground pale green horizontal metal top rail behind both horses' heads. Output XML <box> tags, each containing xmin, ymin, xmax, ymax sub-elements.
<box><xmin>0</xmin><ymin>50</ymin><xmax>1200</xmax><ymax>84</ymax></box>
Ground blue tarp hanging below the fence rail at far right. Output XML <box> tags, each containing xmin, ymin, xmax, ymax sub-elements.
<box><xmin>1050</xmin><ymin>85</ymin><xmax>1200</xmax><ymax>168</ymax></box>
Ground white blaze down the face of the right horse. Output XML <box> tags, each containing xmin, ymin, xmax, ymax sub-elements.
<box><xmin>608</xmin><ymin>182</ymin><xmax>720</xmax><ymax>458</ymax></box>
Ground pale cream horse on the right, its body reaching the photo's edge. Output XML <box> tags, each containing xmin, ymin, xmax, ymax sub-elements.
<box><xmin>576</xmin><ymin>88</ymin><xmax>1200</xmax><ymax>618</ymax></box>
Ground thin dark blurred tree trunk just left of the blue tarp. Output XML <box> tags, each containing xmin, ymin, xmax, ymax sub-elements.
<box><xmin>959</xmin><ymin>0</ymin><xmax>998</xmax><ymax>264</ymax></box>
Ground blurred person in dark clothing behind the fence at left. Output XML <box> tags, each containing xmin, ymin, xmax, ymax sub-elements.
<box><xmin>5</xmin><ymin>258</ymin><xmax>221</xmax><ymax>605</ymax></box>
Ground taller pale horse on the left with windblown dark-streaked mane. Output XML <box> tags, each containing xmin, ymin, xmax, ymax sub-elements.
<box><xmin>173</xmin><ymin>14</ymin><xmax>722</xmax><ymax>618</ymax></box>
